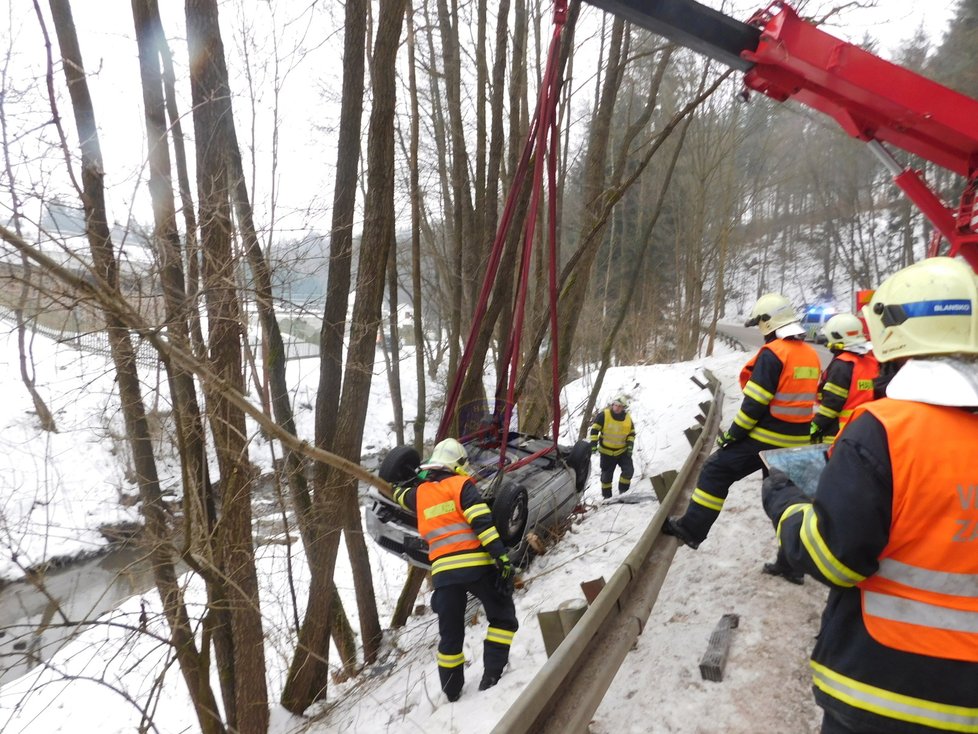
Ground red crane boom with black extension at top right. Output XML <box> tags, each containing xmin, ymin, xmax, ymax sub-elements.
<box><xmin>588</xmin><ymin>0</ymin><xmax>978</xmax><ymax>270</ymax></box>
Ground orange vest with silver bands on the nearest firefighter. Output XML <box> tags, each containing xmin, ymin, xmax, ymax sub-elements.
<box><xmin>854</xmin><ymin>398</ymin><xmax>978</xmax><ymax>663</ymax></box>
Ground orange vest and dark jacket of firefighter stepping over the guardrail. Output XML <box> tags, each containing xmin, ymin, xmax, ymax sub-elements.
<box><xmin>731</xmin><ymin>339</ymin><xmax>821</xmax><ymax>447</ymax></box>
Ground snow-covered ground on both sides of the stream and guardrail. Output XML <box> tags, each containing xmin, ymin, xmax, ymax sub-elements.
<box><xmin>0</xmin><ymin>333</ymin><xmax>825</xmax><ymax>734</ymax></box>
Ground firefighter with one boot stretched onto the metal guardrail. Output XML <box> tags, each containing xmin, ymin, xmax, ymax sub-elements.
<box><xmin>662</xmin><ymin>293</ymin><xmax>821</xmax><ymax>583</ymax></box>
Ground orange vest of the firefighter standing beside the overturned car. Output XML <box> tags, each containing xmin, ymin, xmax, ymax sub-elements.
<box><xmin>416</xmin><ymin>475</ymin><xmax>492</xmax><ymax>573</ymax></box>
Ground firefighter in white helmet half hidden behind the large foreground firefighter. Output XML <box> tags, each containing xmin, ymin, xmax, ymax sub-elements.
<box><xmin>811</xmin><ymin>313</ymin><xmax>880</xmax><ymax>443</ymax></box>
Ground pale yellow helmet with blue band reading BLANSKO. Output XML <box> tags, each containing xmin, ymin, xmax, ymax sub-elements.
<box><xmin>863</xmin><ymin>257</ymin><xmax>978</xmax><ymax>362</ymax></box>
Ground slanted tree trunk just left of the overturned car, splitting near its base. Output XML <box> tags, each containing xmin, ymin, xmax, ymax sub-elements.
<box><xmin>282</xmin><ymin>0</ymin><xmax>405</xmax><ymax>711</ymax></box>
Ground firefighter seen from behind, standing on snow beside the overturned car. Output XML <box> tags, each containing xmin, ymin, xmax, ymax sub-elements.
<box><xmin>394</xmin><ymin>438</ymin><xmax>519</xmax><ymax>701</ymax></box>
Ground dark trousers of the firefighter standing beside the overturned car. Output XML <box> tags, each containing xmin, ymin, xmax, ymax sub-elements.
<box><xmin>431</xmin><ymin>568</ymin><xmax>519</xmax><ymax>697</ymax></box>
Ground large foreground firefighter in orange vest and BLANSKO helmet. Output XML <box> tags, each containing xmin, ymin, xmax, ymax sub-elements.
<box><xmin>763</xmin><ymin>257</ymin><xmax>978</xmax><ymax>734</ymax></box>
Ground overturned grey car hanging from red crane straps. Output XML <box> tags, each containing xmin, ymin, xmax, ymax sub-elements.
<box><xmin>366</xmin><ymin>432</ymin><xmax>591</xmax><ymax>568</ymax></box>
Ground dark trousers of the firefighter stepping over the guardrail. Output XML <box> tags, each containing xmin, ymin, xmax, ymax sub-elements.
<box><xmin>679</xmin><ymin>438</ymin><xmax>777</xmax><ymax>543</ymax></box>
